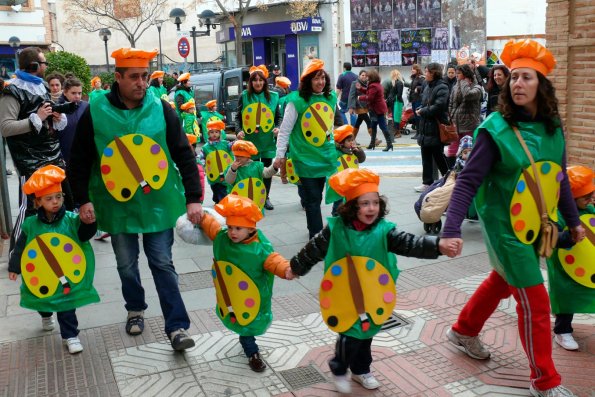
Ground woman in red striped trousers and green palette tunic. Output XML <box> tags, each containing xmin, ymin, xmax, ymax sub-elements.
<box><xmin>442</xmin><ymin>40</ymin><xmax>585</xmax><ymax>397</ymax></box>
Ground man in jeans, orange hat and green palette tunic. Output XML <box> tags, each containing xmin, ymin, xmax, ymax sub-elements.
<box><xmin>68</xmin><ymin>48</ymin><xmax>202</xmax><ymax>351</ymax></box>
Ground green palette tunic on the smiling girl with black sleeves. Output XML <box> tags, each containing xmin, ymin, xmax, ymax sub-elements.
<box><xmin>320</xmin><ymin>218</ymin><xmax>399</xmax><ymax>339</ymax></box>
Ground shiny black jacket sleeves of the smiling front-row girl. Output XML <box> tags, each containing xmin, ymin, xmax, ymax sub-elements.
<box><xmin>290</xmin><ymin>220</ymin><xmax>440</xmax><ymax>276</ymax></box>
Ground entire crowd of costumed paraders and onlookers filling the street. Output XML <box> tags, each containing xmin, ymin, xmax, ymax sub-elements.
<box><xmin>0</xmin><ymin>40</ymin><xmax>595</xmax><ymax>397</ymax></box>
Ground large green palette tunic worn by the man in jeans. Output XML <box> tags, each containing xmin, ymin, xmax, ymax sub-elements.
<box><xmin>89</xmin><ymin>88</ymin><xmax>186</xmax><ymax>234</ymax></box>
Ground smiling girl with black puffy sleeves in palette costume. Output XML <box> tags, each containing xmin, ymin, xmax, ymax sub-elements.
<box><xmin>291</xmin><ymin>168</ymin><xmax>457</xmax><ymax>393</ymax></box>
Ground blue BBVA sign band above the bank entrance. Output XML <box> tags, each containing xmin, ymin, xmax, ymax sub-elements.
<box><xmin>229</xmin><ymin>17</ymin><xmax>322</xmax><ymax>40</ymax></box>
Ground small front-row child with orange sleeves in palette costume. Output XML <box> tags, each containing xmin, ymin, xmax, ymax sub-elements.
<box><xmin>201</xmin><ymin>194</ymin><xmax>293</xmax><ymax>372</ymax></box>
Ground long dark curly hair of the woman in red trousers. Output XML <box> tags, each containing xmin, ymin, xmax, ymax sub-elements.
<box><xmin>498</xmin><ymin>71</ymin><xmax>561</xmax><ymax>135</ymax></box>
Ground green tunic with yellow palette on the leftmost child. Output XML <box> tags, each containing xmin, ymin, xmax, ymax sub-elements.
<box><xmin>21</xmin><ymin>211</ymin><xmax>99</xmax><ymax>312</ymax></box>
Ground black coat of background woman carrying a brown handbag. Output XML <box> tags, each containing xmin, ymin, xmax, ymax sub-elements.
<box><xmin>417</xmin><ymin>79</ymin><xmax>448</xmax><ymax>146</ymax></box>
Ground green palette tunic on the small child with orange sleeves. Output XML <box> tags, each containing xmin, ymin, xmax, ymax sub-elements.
<box><xmin>212</xmin><ymin>228</ymin><xmax>274</xmax><ymax>336</ymax></box>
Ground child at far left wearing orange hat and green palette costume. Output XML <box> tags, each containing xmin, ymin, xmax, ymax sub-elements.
<box><xmin>8</xmin><ymin>165</ymin><xmax>99</xmax><ymax>354</ymax></box>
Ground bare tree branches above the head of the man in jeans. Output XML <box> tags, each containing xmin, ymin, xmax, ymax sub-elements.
<box><xmin>64</xmin><ymin>0</ymin><xmax>167</xmax><ymax>47</ymax></box>
